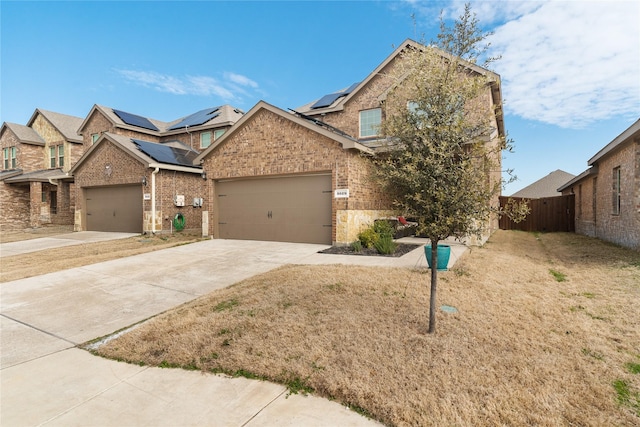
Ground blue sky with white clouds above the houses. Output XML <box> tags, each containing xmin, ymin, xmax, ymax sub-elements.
<box><xmin>0</xmin><ymin>0</ymin><xmax>640</xmax><ymax>195</ymax></box>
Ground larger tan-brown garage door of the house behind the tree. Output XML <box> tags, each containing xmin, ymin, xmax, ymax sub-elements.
<box><xmin>216</xmin><ymin>175</ymin><xmax>332</xmax><ymax>244</ymax></box>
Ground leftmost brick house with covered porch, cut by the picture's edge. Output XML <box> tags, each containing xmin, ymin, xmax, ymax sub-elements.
<box><xmin>0</xmin><ymin>109</ymin><xmax>83</xmax><ymax>229</ymax></box>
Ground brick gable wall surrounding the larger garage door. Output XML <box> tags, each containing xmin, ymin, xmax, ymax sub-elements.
<box><xmin>203</xmin><ymin>109</ymin><xmax>388</xmax><ymax>243</ymax></box>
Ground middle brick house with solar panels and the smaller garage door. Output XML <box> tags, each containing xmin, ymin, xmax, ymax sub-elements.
<box><xmin>71</xmin><ymin>105</ymin><xmax>244</xmax><ymax>235</ymax></box>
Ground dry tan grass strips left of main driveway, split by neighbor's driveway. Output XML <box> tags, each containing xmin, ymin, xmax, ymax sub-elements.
<box><xmin>0</xmin><ymin>227</ymin><xmax>202</xmax><ymax>283</ymax></box>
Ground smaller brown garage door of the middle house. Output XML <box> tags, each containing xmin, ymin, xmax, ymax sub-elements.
<box><xmin>84</xmin><ymin>185</ymin><xmax>142</xmax><ymax>233</ymax></box>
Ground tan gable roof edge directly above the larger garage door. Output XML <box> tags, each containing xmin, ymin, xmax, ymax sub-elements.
<box><xmin>195</xmin><ymin>101</ymin><xmax>373</xmax><ymax>164</ymax></box>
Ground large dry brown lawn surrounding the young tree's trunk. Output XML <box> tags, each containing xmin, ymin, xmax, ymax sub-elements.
<box><xmin>91</xmin><ymin>231</ymin><xmax>640</xmax><ymax>426</ymax></box>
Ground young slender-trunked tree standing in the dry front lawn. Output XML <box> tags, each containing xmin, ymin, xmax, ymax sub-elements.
<box><xmin>375</xmin><ymin>4</ymin><xmax>524</xmax><ymax>333</ymax></box>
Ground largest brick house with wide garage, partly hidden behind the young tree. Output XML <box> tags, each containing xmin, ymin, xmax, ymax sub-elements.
<box><xmin>196</xmin><ymin>40</ymin><xmax>504</xmax><ymax>244</ymax></box>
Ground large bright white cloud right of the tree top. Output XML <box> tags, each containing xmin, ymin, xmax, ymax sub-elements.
<box><xmin>484</xmin><ymin>1</ymin><xmax>640</xmax><ymax>128</ymax></box>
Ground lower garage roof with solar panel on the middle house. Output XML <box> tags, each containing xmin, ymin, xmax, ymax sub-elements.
<box><xmin>69</xmin><ymin>132</ymin><xmax>202</xmax><ymax>175</ymax></box>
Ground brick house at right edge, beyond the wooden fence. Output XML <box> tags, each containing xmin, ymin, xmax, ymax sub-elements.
<box><xmin>558</xmin><ymin>120</ymin><xmax>640</xmax><ymax>249</ymax></box>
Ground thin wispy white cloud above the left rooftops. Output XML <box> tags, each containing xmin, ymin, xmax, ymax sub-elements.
<box><xmin>115</xmin><ymin>70</ymin><xmax>258</xmax><ymax>102</ymax></box>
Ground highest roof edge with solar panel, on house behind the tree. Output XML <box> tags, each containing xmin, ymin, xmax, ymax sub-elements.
<box><xmin>296</xmin><ymin>39</ymin><xmax>505</xmax><ymax>135</ymax></box>
